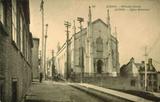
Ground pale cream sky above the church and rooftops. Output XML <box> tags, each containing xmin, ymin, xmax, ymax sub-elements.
<box><xmin>30</xmin><ymin>0</ymin><xmax>160</xmax><ymax>65</ymax></box>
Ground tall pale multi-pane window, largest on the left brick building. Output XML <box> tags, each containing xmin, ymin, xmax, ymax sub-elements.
<box><xmin>12</xmin><ymin>0</ymin><xmax>17</xmax><ymax>44</ymax></box>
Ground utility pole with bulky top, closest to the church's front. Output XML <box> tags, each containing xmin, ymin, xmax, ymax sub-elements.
<box><xmin>77</xmin><ymin>17</ymin><xmax>84</xmax><ymax>83</ymax></box>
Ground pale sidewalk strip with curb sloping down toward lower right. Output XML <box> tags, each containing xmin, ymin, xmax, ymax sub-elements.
<box><xmin>70</xmin><ymin>83</ymin><xmax>152</xmax><ymax>102</ymax></box>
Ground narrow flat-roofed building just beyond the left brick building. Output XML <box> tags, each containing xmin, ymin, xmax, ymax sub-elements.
<box><xmin>32</xmin><ymin>38</ymin><xmax>39</xmax><ymax>79</ymax></box>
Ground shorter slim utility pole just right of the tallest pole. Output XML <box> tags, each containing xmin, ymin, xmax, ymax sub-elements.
<box><xmin>44</xmin><ymin>24</ymin><xmax>48</xmax><ymax>79</ymax></box>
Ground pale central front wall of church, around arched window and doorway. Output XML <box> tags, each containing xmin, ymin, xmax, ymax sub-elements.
<box><xmin>93</xmin><ymin>22</ymin><xmax>108</xmax><ymax>73</ymax></box>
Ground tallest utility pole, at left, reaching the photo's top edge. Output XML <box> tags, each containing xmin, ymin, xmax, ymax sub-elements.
<box><xmin>40</xmin><ymin>0</ymin><xmax>45</xmax><ymax>79</ymax></box>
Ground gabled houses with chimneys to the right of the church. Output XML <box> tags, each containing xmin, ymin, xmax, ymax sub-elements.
<box><xmin>120</xmin><ymin>58</ymin><xmax>160</xmax><ymax>91</ymax></box>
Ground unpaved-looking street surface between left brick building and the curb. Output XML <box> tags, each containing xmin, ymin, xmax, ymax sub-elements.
<box><xmin>26</xmin><ymin>81</ymin><xmax>103</xmax><ymax>102</ymax></box>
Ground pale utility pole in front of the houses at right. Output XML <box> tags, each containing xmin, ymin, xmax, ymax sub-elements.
<box><xmin>144</xmin><ymin>46</ymin><xmax>148</xmax><ymax>91</ymax></box>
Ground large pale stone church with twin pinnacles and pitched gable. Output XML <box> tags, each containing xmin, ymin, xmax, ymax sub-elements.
<box><xmin>56</xmin><ymin>7</ymin><xmax>119</xmax><ymax>76</ymax></box>
